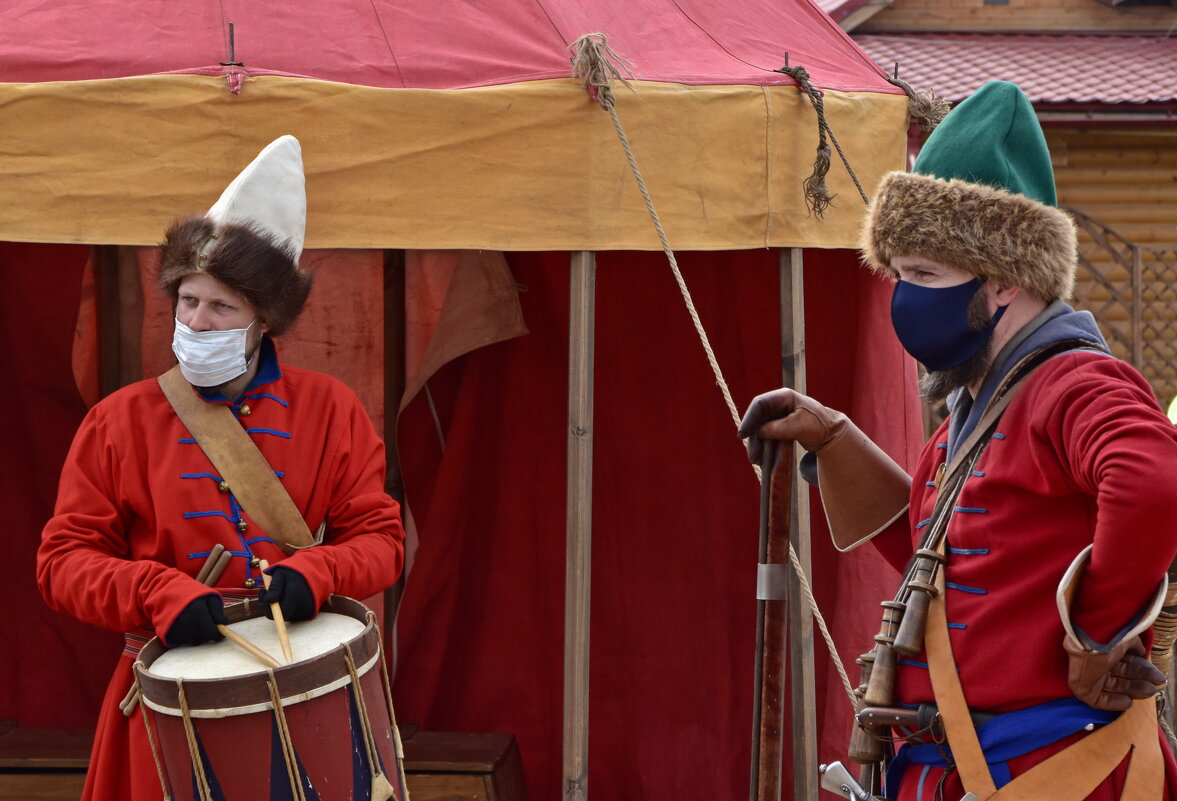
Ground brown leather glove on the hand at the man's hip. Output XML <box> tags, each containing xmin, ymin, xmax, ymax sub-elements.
<box><xmin>1063</xmin><ymin>634</ymin><xmax>1165</xmax><ymax>712</ymax></box>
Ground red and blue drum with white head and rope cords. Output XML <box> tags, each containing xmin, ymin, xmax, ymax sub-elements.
<box><xmin>135</xmin><ymin>596</ymin><xmax>407</xmax><ymax>801</ymax></box>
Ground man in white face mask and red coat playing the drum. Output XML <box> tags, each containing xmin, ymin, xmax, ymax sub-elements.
<box><xmin>38</xmin><ymin>136</ymin><xmax>404</xmax><ymax>800</ymax></box>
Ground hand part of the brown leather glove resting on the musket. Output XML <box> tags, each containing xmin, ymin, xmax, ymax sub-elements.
<box><xmin>739</xmin><ymin>389</ymin><xmax>850</xmax><ymax>465</ymax></box>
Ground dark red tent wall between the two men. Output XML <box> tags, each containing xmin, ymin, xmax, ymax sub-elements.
<box><xmin>395</xmin><ymin>251</ymin><xmax>919</xmax><ymax>799</ymax></box>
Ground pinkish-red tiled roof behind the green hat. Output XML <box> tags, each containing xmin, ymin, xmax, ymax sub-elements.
<box><xmin>853</xmin><ymin>33</ymin><xmax>1177</xmax><ymax>104</ymax></box>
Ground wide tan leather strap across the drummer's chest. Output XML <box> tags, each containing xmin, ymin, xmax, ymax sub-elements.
<box><xmin>159</xmin><ymin>365</ymin><xmax>314</xmax><ymax>554</ymax></box>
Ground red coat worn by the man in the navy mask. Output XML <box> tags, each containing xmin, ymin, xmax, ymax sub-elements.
<box><xmin>877</xmin><ymin>352</ymin><xmax>1177</xmax><ymax>799</ymax></box>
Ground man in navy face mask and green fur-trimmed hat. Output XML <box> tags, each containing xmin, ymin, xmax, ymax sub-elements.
<box><xmin>740</xmin><ymin>82</ymin><xmax>1177</xmax><ymax>801</ymax></box>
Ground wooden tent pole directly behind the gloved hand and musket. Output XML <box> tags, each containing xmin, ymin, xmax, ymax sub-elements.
<box><xmin>780</xmin><ymin>247</ymin><xmax>818</xmax><ymax>799</ymax></box>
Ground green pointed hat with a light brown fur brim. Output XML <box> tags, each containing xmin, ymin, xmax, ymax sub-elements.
<box><xmin>862</xmin><ymin>81</ymin><xmax>1076</xmax><ymax>300</ymax></box>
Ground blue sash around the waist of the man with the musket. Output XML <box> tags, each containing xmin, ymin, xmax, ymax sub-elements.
<box><xmin>886</xmin><ymin>699</ymin><xmax>1121</xmax><ymax>799</ymax></box>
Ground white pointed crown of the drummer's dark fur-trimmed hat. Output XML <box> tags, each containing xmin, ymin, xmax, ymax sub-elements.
<box><xmin>206</xmin><ymin>134</ymin><xmax>306</xmax><ymax>263</ymax></box>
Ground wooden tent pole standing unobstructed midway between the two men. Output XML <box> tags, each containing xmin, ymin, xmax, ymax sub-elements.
<box><xmin>564</xmin><ymin>251</ymin><xmax>597</xmax><ymax>801</ymax></box>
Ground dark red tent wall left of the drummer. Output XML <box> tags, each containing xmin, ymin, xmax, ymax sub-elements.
<box><xmin>0</xmin><ymin>242</ymin><xmax>122</xmax><ymax>728</ymax></box>
